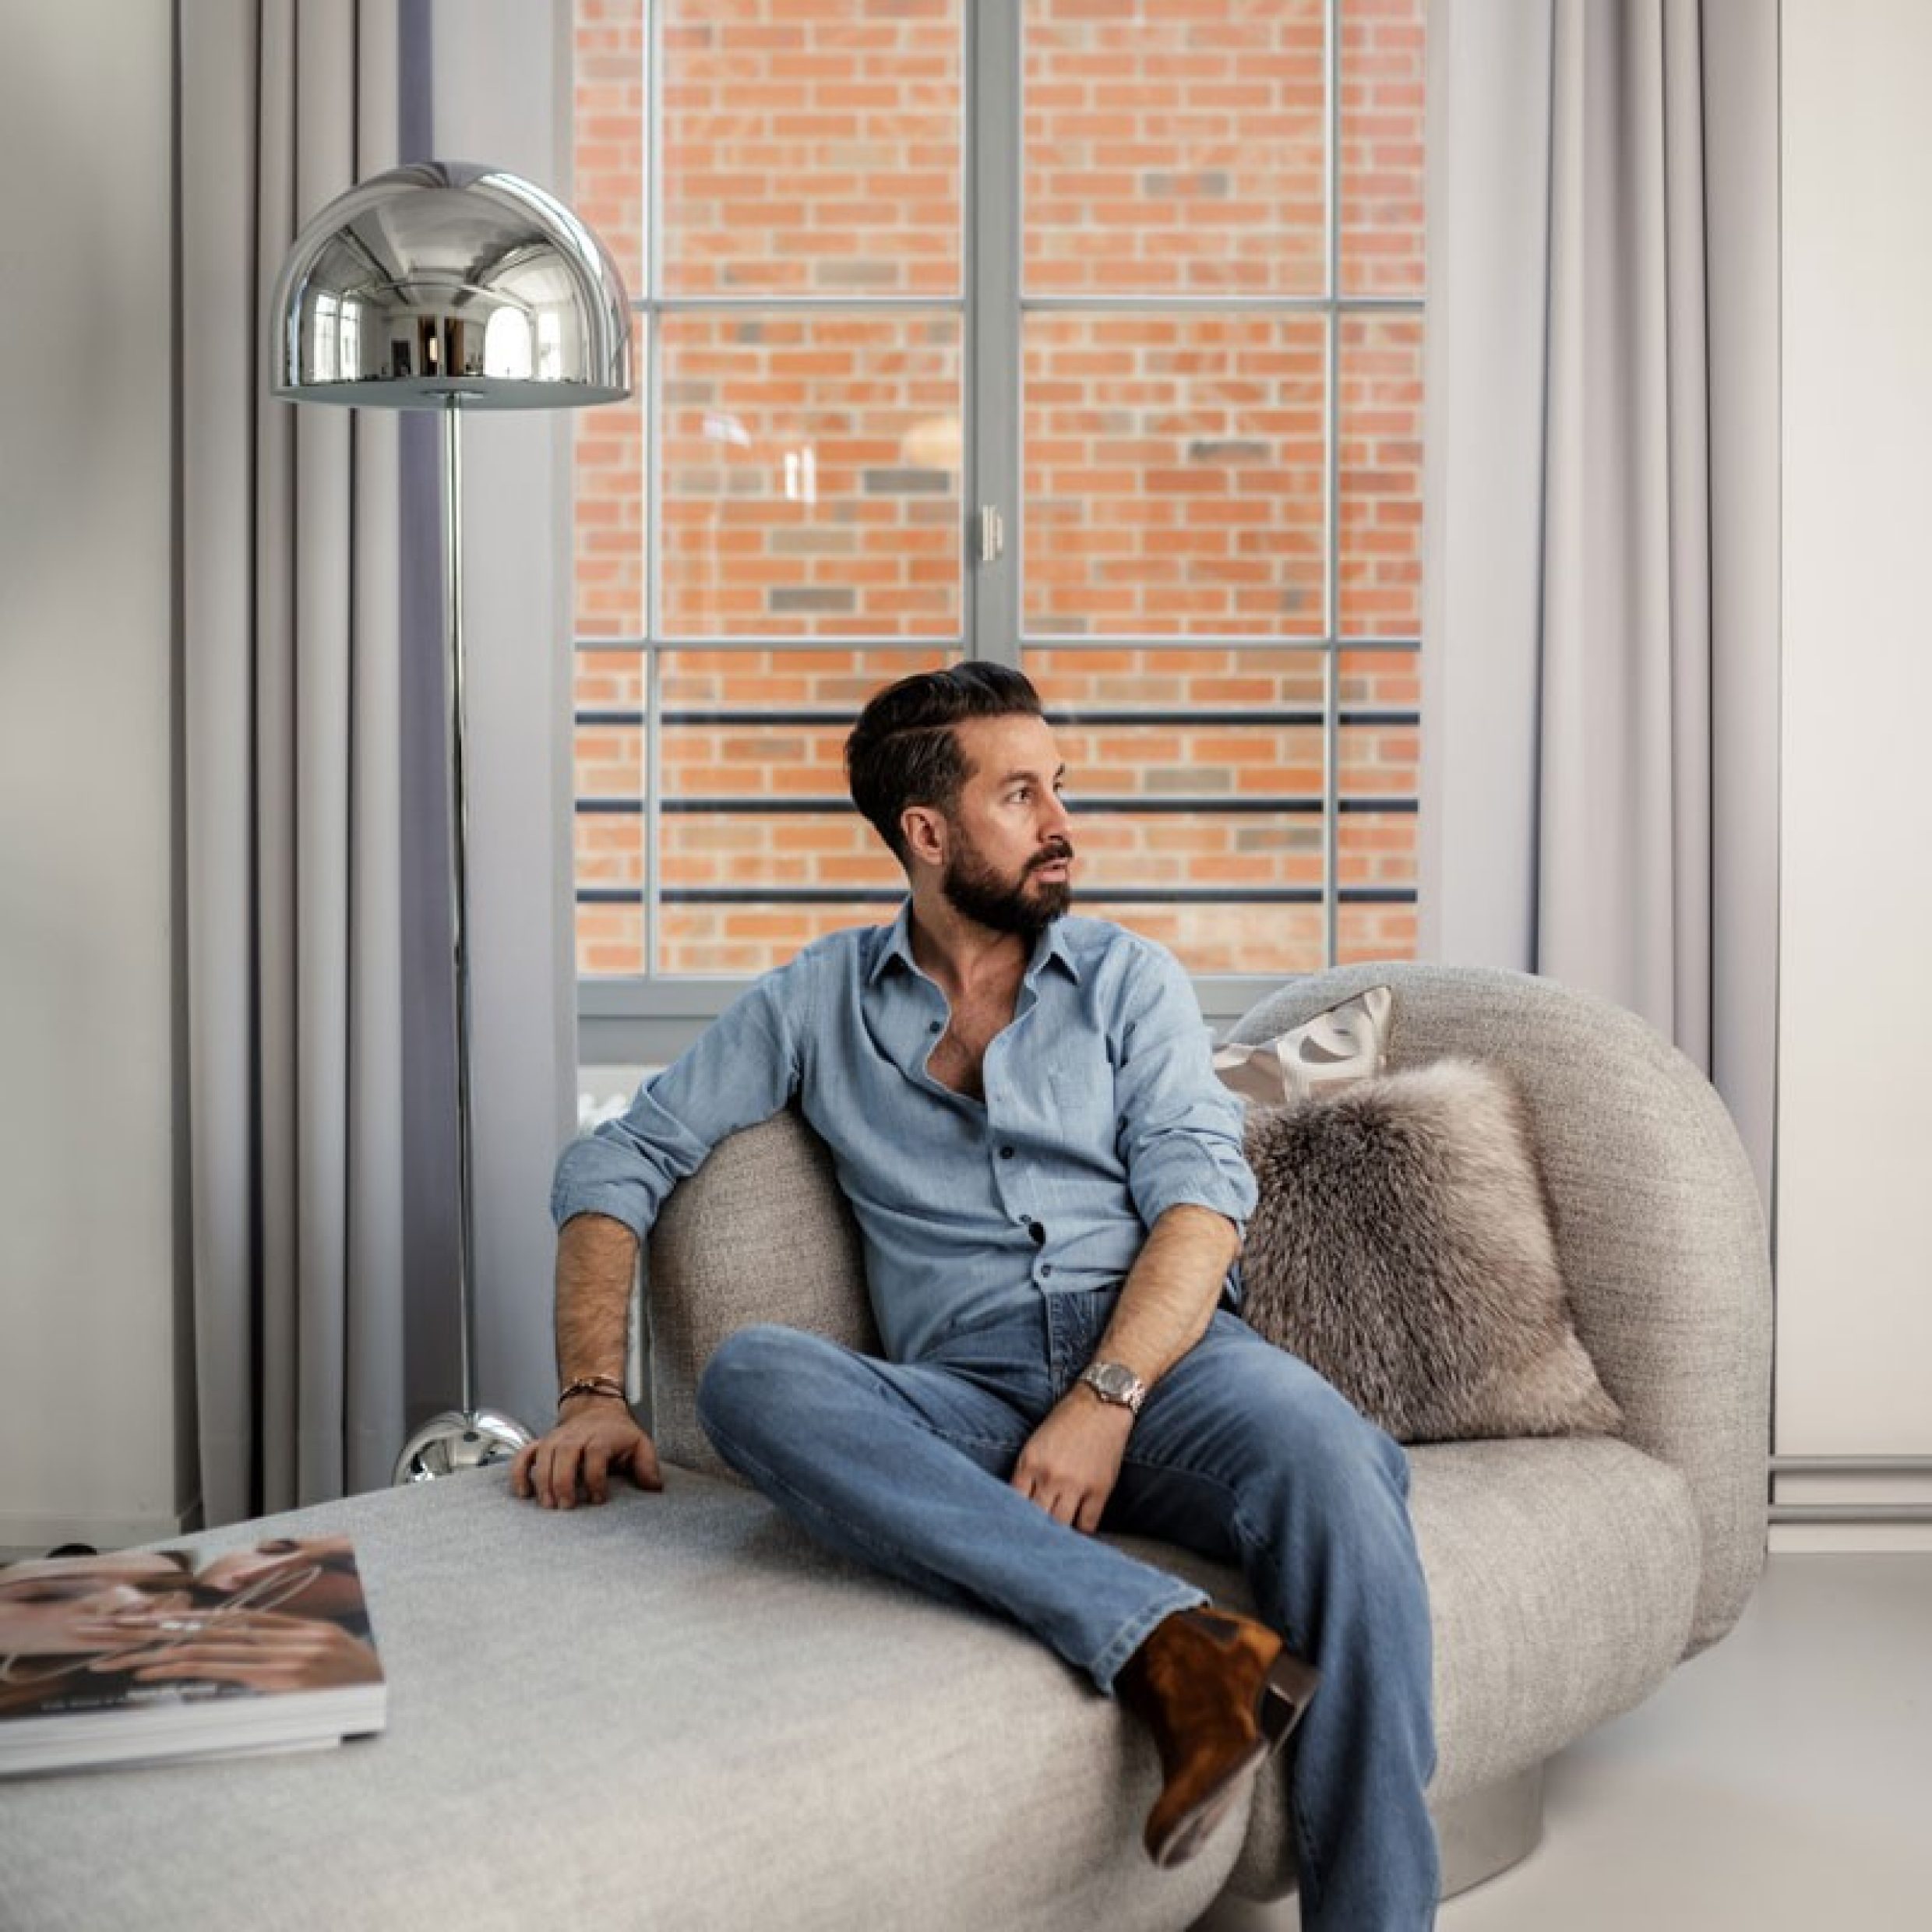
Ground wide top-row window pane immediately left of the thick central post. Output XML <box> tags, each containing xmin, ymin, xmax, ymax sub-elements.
<box><xmin>663</xmin><ymin>0</ymin><xmax>961</xmax><ymax>295</ymax></box>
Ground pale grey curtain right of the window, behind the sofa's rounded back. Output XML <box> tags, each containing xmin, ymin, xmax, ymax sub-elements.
<box><xmin>1422</xmin><ymin>0</ymin><xmax>1779</xmax><ymax>1198</ymax></box>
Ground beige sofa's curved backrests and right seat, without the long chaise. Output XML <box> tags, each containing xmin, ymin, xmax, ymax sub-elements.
<box><xmin>649</xmin><ymin>964</ymin><xmax>1772</xmax><ymax>1897</ymax></box>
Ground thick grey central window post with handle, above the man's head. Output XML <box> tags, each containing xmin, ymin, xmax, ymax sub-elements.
<box><xmin>962</xmin><ymin>0</ymin><xmax>1024</xmax><ymax>665</ymax></box>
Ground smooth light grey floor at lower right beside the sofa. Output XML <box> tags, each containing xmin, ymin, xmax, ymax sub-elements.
<box><xmin>1197</xmin><ymin>1555</ymin><xmax>1932</xmax><ymax>1932</ymax></box>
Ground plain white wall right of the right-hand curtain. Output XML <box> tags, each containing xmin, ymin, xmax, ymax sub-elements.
<box><xmin>1778</xmin><ymin>0</ymin><xmax>1932</xmax><ymax>1546</ymax></box>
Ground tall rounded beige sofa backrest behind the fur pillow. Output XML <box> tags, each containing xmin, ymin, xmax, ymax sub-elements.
<box><xmin>1229</xmin><ymin>964</ymin><xmax>1772</xmax><ymax>1650</ymax></box>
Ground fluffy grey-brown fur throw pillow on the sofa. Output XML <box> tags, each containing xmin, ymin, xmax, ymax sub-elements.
<box><xmin>1240</xmin><ymin>1059</ymin><xmax>1623</xmax><ymax>1441</ymax></box>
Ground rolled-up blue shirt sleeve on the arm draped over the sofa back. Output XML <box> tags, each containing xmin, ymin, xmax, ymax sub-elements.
<box><xmin>551</xmin><ymin>950</ymin><xmax>813</xmax><ymax>1240</ymax></box>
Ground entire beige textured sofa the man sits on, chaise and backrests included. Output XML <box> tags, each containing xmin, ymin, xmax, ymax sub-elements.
<box><xmin>0</xmin><ymin>966</ymin><xmax>1770</xmax><ymax>1932</ymax></box>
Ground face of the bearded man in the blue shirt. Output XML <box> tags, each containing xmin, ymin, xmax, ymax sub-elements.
<box><xmin>939</xmin><ymin>717</ymin><xmax>1074</xmax><ymax>939</ymax></box>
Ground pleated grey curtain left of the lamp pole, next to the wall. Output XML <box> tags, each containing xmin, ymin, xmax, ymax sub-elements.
<box><xmin>178</xmin><ymin>0</ymin><xmax>404</xmax><ymax>1522</ymax></box>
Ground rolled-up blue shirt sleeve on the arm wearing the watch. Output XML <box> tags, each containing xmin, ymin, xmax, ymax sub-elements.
<box><xmin>1115</xmin><ymin>945</ymin><xmax>1254</xmax><ymax>1229</ymax></box>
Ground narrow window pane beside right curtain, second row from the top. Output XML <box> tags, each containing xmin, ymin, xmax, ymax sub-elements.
<box><xmin>1337</xmin><ymin>315</ymin><xmax>1422</xmax><ymax>637</ymax></box>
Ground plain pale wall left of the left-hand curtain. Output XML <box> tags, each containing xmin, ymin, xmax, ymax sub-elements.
<box><xmin>0</xmin><ymin>0</ymin><xmax>188</xmax><ymax>1547</ymax></box>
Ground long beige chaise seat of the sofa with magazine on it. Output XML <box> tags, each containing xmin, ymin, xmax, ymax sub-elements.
<box><xmin>0</xmin><ymin>1468</ymin><xmax>1240</xmax><ymax>1932</ymax></box>
